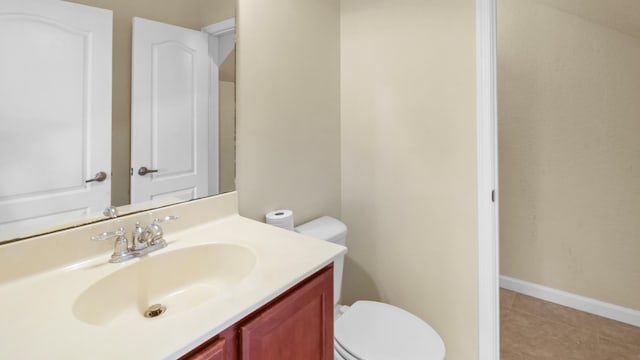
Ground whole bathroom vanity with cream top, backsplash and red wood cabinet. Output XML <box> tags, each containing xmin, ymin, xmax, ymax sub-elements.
<box><xmin>0</xmin><ymin>193</ymin><xmax>346</xmax><ymax>360</ymax></box>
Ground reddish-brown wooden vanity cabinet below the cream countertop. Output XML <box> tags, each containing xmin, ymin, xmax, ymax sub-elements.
<box><xmin>182</xmin><ymin>265</ymin><xmax>333</xmax><ymax>360</ymax></box>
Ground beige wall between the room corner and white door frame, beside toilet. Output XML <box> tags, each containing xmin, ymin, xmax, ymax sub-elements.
<box><xmin>342</xmin><ymin>0</ymin><xmax>478</xmax><ymax>360</ymax></box>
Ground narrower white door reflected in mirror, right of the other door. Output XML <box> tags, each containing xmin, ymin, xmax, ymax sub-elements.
<box><xmin>131</xmin><ymin>18</ymin><xmax>209</xmax><ymax>204</ymax></box>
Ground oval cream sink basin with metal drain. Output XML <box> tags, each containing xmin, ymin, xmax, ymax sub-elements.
<box><xmin>73</xmin><ymin>243</ymin><xmax>256</xmax><ymax>326</ymax></box>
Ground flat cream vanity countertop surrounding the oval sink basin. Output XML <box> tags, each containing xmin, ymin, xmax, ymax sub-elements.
<box><xmin>0</xmin><ymin>210</ymin><xmax>346</xmax><ymax>359</ymax></box>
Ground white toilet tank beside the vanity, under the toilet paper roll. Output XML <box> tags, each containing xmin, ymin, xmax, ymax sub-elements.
<box><xmin>295</xmin><ymin>216</ymin><xmax>347</xmax><ymax>305</ymax></box>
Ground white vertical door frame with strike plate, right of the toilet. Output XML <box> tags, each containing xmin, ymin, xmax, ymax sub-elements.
<box><xmin>476</xmin><ymin>0</ymin><xmax>500</xmax><ymax>360</ymax></box>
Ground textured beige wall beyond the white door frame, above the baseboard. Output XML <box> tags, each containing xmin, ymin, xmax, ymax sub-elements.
<box><xmin>498</xmin><ymin>0</ymin><xmax>640</xmax><ymax>309</ymax></box>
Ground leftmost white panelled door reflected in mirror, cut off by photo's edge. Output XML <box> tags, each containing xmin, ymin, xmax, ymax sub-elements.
<box><xmin>0</xmin><ymin>0</ymin><xmax>112</xmax><ymax>238</ymax></box>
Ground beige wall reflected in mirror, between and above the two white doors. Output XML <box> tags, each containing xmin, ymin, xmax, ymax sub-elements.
<box><xmin>71</xmin><ymin>0</ymin><xmax>235</xmax><ymax>206</ymax></box>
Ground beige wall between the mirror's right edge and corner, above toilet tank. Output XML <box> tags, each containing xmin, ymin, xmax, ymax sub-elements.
<box><xmin>236</xmin><ymin>0</ymin><xmax>340</xmax><ymax>224</ymax></box>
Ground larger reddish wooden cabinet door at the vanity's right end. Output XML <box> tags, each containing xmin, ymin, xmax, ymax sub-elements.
<box><xmin>240</xmin><ymin>267</ymin><xmax>333</xmax><ymax>360</ymax></box>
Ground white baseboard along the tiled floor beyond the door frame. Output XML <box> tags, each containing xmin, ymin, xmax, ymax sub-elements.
<box><xmin>500</xmin><ymin>275</ymin><xmax>640</xmax><ymax>327</ymax></box>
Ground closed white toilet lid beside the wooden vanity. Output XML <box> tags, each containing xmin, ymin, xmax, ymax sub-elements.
<box><xmin>335</xmin><ymin>301</ymin><xmax>445</xmax><ymax>360</ymax></box>
